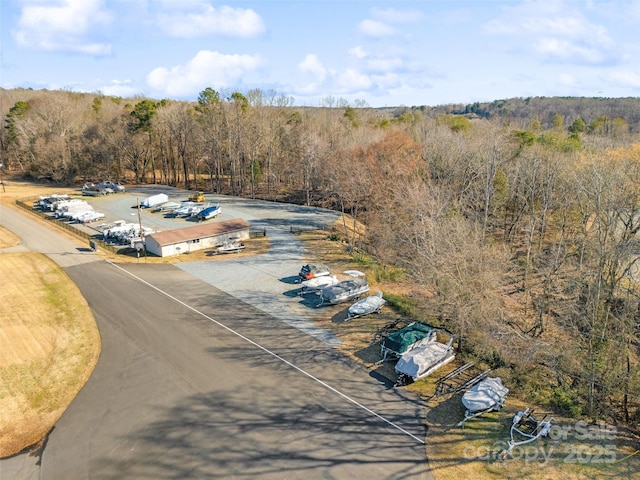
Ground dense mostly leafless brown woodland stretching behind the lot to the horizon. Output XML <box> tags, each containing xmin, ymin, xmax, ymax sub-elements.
<box><xmin>0</xmin><ymin>88</ymin><xmax>640</xmax><ymax>430</ymax></box>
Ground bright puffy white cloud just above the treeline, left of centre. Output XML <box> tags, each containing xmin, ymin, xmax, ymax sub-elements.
<box><xmin>147</xmin><ymin>50</ymin><xmax>263</xmax><ymax>96</ymax></box>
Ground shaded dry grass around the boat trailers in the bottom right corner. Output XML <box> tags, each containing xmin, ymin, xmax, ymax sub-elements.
<box><xmin>427</xmin><ymin>394</ymin><xmax>640</xmax><ymax>480</ymax></box>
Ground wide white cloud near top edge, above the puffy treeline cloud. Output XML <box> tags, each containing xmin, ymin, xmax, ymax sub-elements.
<box><xmin>158</xmin><ymin>2</ymin><xmax>266</xmax><ymax>38</ymax></box>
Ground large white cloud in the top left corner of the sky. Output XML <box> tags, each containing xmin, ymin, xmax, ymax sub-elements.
<box><xmin>13</xmin><ymin>0</ymin><xmax>111</xmax><ymax>55</ymax></box>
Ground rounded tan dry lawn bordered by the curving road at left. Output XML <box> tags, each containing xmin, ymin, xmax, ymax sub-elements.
<box><xmin>0</xmin><ymin>249</ymin><xmax>100</xmax><ymax>457</ymax></box>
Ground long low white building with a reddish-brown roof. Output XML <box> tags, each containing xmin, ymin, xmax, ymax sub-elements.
<box><xmin>145</xmin><ymin>218</ymin><xmax>249</xmax><ymax>257</ymax></box>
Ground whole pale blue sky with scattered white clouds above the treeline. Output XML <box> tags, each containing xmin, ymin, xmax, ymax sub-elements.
<box><xmin>0</xmin><ymin>0</ymin><xmax>640</xmax><ymax>107</ymax></box>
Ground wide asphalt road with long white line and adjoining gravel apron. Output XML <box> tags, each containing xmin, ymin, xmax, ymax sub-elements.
<box><xmin>0</xmin><ymin>194</ymin><xmax>430</xmax><ymax>480</ymax></box>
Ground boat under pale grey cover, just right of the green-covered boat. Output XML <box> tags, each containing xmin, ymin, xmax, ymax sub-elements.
<box><xmin>395</xmin><ymin>337</ymin><xmax>455</xmax><ymax>385</ymax></box>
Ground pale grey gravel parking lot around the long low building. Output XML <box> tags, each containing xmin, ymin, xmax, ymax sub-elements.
<box><xmin>84</xmin><ymin>187</ymin><xmax>340</xmax><ymax>346</ymax></box>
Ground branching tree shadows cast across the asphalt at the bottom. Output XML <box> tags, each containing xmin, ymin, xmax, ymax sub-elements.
<box><xmin>92</xmin><ymin>376</ymin><xmax>428</xmax><ymax>479</ymax></box>
